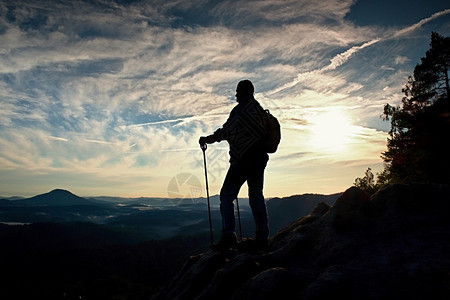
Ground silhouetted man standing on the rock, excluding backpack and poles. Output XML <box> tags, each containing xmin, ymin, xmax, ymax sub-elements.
<box><xmin>199</xmin><ymin>80</ymin><xmax>269</xmax><ymax>250</ymax></box>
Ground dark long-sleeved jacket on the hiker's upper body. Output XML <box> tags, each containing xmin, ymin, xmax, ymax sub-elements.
<box><xmin>214</xmin><ymin>97</ymin><xmax>269</xmax><ymax>163</ymax></box>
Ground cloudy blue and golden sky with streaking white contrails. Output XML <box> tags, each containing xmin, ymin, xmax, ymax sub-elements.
<box><xmin>0</xmin><ymin>0</ymin><xmax>450</xmax><ymax>198</ymax></box>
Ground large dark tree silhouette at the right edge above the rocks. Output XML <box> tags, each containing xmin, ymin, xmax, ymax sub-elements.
<box><xmin>382</xmin><ymin>32</ymin><xmax>450</xmax><ymax>183</ymax></box>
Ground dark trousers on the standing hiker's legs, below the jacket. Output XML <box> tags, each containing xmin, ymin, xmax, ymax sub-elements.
<box><xmin>220</xmin><ymin>159</ymin><xmax>269</xmax><ymax>239</ymax></box>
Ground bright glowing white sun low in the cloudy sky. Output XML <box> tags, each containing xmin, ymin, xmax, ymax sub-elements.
<box><xmin>309</xmin><ymin>108</ymin><xmax>356</xmax><ymax>152</ymax></box>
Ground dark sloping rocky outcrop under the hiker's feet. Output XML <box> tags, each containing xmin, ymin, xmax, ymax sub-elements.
<box><xmin>154</xmin><ymin>184</ymin><xmax>450</xmax><ymax>300</ymax></box>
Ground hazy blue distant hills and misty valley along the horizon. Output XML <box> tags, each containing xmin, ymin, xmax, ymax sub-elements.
<box><xmin>0</xmin><ymin>189</ymin><xmax>337</xmax><ymax>239</ymax></box>
